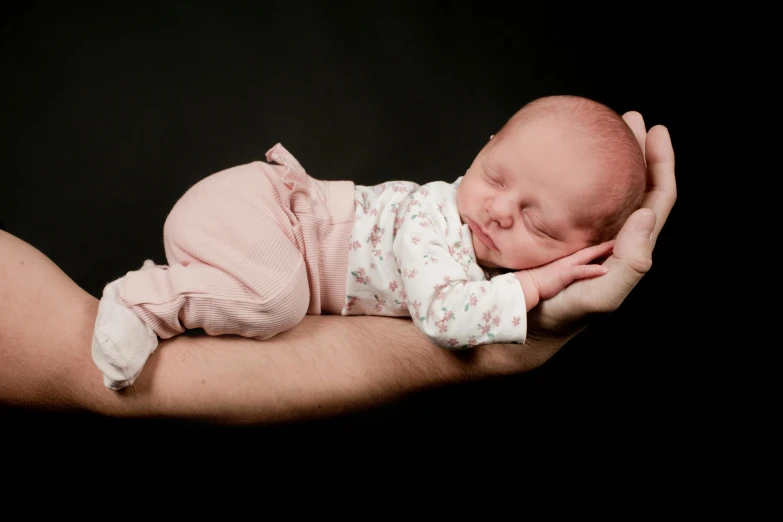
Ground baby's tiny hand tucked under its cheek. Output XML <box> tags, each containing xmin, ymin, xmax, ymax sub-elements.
<box><xmin>516</xmin><ymin>240</ymin><xmax>614</xmax><ymax>311</ymax></box>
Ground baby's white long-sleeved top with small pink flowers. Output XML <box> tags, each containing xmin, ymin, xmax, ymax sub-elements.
<box><xmin>342</xmin><ymin>177</ymin><xmax>527</xmax><ymax>349</ymax></box>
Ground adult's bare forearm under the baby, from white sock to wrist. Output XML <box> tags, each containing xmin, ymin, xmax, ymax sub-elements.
<box><xmin>95</xmin><ymin>310</ymin><xmax>559</xmax><ymax>424</ymax></box>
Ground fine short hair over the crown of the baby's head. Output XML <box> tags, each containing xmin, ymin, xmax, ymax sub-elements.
<box><xmin>506</xmin><ymin>95</ymin><xmax>647</xmax><ymax>243</ymax></box>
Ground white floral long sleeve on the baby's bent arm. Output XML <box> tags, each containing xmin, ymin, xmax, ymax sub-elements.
<box><xmin>394</xmin><ymin>182</ymin><xmax>527</xmax><ymax>349</ymax></box>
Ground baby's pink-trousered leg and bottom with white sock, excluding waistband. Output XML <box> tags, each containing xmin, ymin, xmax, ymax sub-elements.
<box><xmin>93</xmin><ymin>162</ymin><xmax>310</xmax><ymax>389</ymax></box>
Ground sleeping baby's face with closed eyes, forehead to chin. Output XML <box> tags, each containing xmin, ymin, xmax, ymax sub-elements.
<box><xmin>457</xmin><ymin>118</ymin><xmax>611</xmax><ymax>270</ymax></box>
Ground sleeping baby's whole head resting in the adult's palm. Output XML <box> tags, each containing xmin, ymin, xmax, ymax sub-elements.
<box><xmin>457</xmin><ymin>96</ymin><xmax>646</xmax><ymax>270</ymax></box>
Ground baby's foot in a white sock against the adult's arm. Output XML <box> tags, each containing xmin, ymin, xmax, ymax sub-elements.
<box><xmin>92</xmin><ymin>278</ymin><xmax>158</xmax><ymax>390</ymax></box>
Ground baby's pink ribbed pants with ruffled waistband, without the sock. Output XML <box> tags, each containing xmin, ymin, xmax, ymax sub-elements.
<box><xmin>120</xmin><ymin>144</ymin><xmax>354</xmax><ymax>340</ymax></box>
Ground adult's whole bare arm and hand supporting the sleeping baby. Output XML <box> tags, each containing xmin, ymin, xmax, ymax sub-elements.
<box><xmin>0</xmin><ymin>113</ymin><xmax>676</xmax><ymax>424</ymax></box>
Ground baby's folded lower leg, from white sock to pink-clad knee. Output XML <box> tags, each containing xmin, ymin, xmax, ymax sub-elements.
<box><xmin>92</xmin><ymin>256</ymin><xmax>310</xmax><ymax>390</ymax></box>
